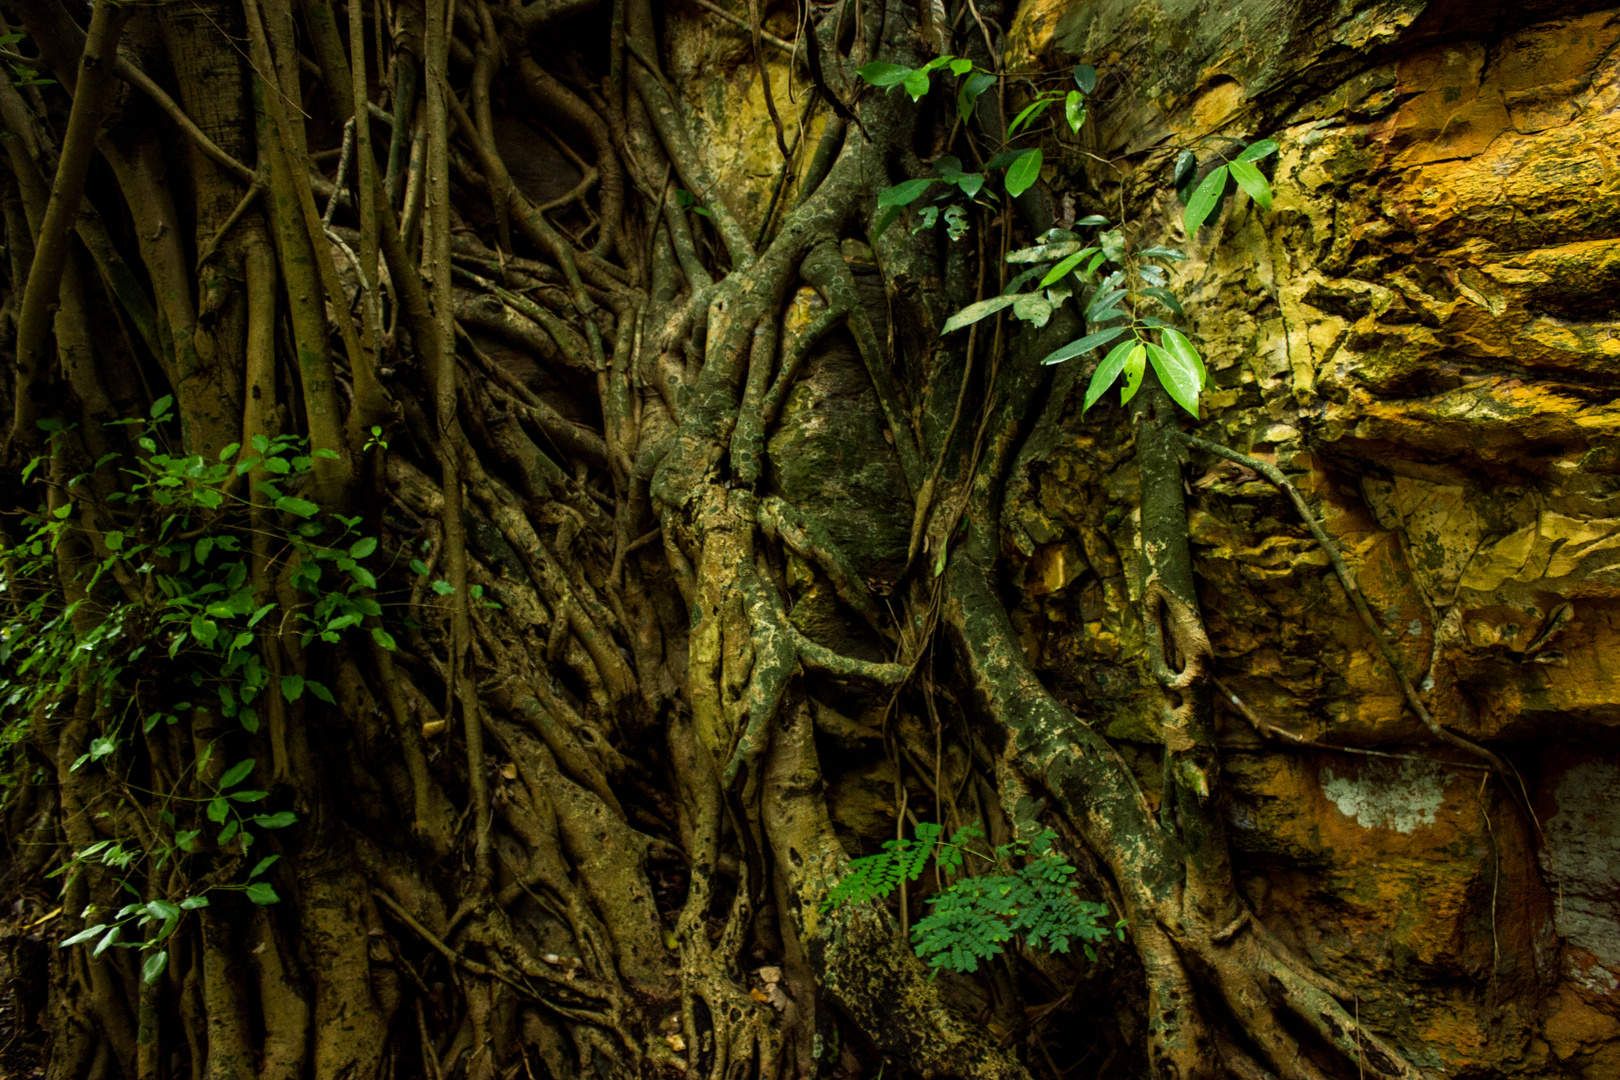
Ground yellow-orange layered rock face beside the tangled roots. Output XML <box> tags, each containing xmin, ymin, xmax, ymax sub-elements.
<box><xmin>1004</xmin><ymin>0</ymin><xmax>1620</xmax><ymax>1080</ymax></box>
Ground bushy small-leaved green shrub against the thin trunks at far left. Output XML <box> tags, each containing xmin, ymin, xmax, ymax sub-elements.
<box><xmin>0</xmin><ymin>397</ymin><xmax>411</xmax><ymax>983</ymax></box>
